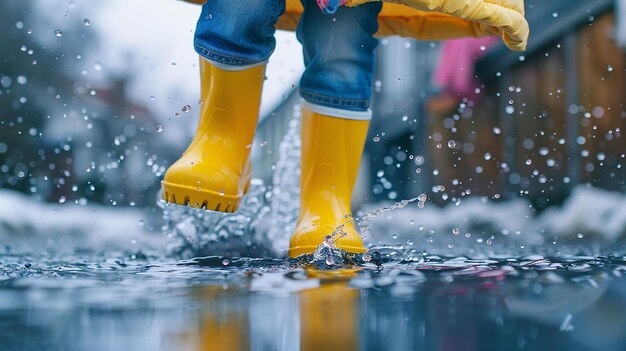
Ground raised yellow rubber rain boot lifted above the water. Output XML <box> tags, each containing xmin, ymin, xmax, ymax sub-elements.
<box><xmin>161</xmin><ymin>58</ymin><xmax>265</xmax><ymax>212</ymax></box>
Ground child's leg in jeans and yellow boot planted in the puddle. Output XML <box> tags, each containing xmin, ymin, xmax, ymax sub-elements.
<box><xmin>289</xmin><ymin>0</ymin><xmax>382</xmax><ymax>257</ymax></box>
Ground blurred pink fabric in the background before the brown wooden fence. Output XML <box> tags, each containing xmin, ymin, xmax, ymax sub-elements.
<box><xmin>433</xmin><ymin>37</ymin><xmax>498</xmax><ymax>98</ymax></box>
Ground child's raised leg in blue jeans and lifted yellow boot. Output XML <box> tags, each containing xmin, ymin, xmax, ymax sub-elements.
<box><xmin>162</xmin><ymin>0</ymin><xmax>284</xmax><ymax>212</ymax></box>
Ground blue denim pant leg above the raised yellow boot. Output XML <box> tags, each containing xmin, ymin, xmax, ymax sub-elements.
<box><xmin>194</xmin><ymin>0</ymin><xmax>285</xmax><ymax>66</ymax></box>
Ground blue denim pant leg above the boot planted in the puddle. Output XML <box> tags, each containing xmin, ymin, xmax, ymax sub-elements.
<box><xmin>297</xmin><ymin>0</ymin><xmax>382</xmax><ymax>111</ymax></box>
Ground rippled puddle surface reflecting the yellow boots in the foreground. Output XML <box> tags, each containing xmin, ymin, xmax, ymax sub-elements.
<box><xmin>0</xmin><ymin>254</ymin><xmax>626</xmax><ymax>350</ymax></box>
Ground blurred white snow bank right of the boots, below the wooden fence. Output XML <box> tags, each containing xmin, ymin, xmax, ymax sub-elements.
<box><xmin>366</xmin><ymin>185</ymin><xmax>626</xmax><ymax>252</ymax></box>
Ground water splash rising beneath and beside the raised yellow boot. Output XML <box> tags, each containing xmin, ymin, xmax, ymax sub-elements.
<box><xmin>158</xmin><ymin>106</ymin><xmax>300</xmax><ymax>257</ymax></box>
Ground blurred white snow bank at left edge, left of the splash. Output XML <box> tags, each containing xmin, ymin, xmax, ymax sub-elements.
<box><xmin>0</xmin><ymin>189</ymin><xmax>164</xmax><ymax>252</ymax></box>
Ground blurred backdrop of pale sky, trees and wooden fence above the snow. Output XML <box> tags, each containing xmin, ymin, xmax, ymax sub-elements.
<box><xmin>0</xmin><ymin>0</ymin><xmax>626</xmax><ymax>248</ymax></box>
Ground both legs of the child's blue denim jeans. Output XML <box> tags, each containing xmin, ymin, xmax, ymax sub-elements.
<box><xmin>194</xmin><ymin>0</ymin><xmax>382</xmax><ymax>111</ymax></box>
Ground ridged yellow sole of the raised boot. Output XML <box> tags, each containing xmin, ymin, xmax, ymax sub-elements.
<box><xmin>161</xmin><ymin>181</ymin><xmax>244</xmax><ymax>213</ymax></box>
